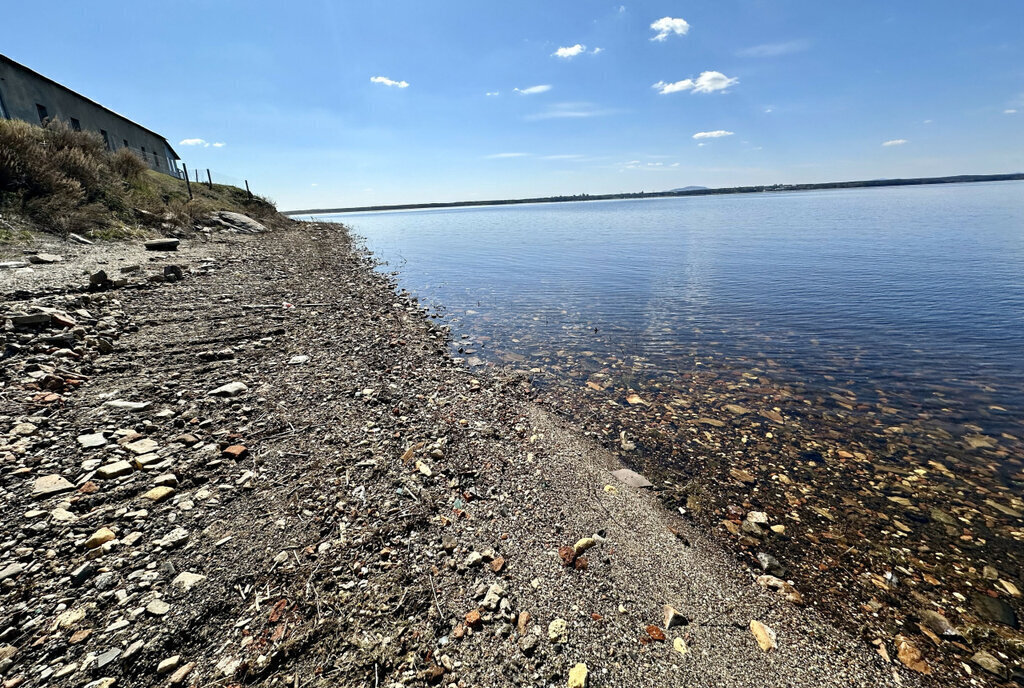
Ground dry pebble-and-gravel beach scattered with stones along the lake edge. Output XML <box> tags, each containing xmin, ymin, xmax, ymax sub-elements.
<box><xmin>0</xmin><ymin>224</ymin><xmax>929</xmax><ymax>688</ymax></box>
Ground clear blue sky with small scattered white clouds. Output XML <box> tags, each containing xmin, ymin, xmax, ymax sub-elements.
<box><xmin>0</xmin><ymin>0</ymin><xmax>1024</xmax><ymax>209</ymax></box>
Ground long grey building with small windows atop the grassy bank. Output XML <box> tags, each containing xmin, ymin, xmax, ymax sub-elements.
<box><xmin>0</xmin><ymin>54</ymin><xmax>181</xmax><ymax>177</ymax></box>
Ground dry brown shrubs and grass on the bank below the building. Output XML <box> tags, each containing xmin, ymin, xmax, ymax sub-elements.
<box><xmin>0</xmin><ymin>120</ymin><xmax>276</xmax><ymax>239</ymax></box>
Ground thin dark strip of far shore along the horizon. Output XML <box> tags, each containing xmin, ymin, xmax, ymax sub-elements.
<box><xmin>282</xmin><ymin>172</ymin><xmax>1024</xmax><ymax>216</ymax></box>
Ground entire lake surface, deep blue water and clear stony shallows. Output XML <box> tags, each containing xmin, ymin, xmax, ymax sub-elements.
<box><xmin>315</xmin><ymin>182</ymin><xmax>1024</xmax><ymax>674</ymax></box>
